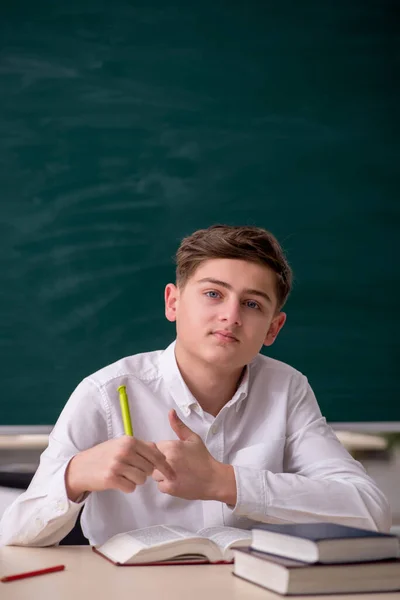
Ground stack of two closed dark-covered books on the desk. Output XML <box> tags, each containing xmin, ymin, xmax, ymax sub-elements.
<box><xmin>233</xmin><ymin>523</ymin><xmax>400</xmax><ymax>595</ymax></box>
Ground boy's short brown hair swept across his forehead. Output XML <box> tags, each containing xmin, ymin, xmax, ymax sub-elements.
<box><xmin>176</xmin><ymin>225</ymin><xmax>292</xmax><ymax>308</ymax></box>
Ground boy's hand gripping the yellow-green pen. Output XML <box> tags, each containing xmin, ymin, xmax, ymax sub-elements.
<box><xmin>65</xmin><ymin>435</ymin><xmax>175</xmax><ymax>502</ymax></box>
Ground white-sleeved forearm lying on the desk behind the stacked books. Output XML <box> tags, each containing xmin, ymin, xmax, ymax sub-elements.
<box><xmin>234</xmin><ymin>467</ymin><xmax>391</xmax><ymax>531</ymax></box>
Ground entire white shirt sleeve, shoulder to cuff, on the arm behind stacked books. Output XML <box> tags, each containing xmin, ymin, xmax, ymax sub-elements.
<box><xmin>233</xmin><ymin>376</ymin><xmax>391</xmax><ymax>532</ymax></box>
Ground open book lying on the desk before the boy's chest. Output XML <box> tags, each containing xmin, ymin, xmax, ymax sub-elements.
<box><xmin>93</xmin><ymin>525</ymin><xmax>251</xmax><ymax>565</ymax></box>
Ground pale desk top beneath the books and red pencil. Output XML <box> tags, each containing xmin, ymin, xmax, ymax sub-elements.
<box><xmin>0</xmin><ymin>546</ymin><xmax>400</xmax><ymax>600</ymax></box>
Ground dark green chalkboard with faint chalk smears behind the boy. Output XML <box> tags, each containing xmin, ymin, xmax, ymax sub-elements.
<box><xmin>0</xmin><ymin>0</ymin><xmax>400</xmax><ymax>425</ymax></box>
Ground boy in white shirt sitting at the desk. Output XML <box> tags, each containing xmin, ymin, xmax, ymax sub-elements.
<box><xmin>0</xmin><ymin>225</ymin><xmax>390</xmax><ymax>546</ymax></box>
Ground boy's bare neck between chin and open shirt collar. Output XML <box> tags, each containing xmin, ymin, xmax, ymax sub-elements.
<box><xmin>175</xmin><ymin>344</ymin><xmax>244</xmax><ymax>417</ymax></box>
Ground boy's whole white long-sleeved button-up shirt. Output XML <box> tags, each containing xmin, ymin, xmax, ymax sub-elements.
<box><xmin>0</xmin><ymin>344</ymin><xmax>390</xmax><ymax>546</ymax></box>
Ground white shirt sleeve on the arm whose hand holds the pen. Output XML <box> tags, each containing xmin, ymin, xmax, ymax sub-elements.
<box><xmin>0</xmin><ymin>379</ymin><xmax>108</xmax><ymax>546</ymax></box>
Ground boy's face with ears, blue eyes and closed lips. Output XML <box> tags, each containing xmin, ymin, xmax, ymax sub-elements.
<box><xmin>165</xmin><ymin>258</ymin><xmax>286</xmax><ymax>370</ymax></box>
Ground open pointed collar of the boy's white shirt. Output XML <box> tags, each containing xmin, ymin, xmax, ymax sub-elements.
<box><xmin>160</xmin><ymin>341</ymin><xmax>250</xmax><ymax>416</ymax></box>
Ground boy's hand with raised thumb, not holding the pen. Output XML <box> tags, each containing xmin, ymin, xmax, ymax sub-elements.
<box><xmin>152</xmin><ymin>410</ymin><xmax>236</xmax><ymax>505</ymax></box>
